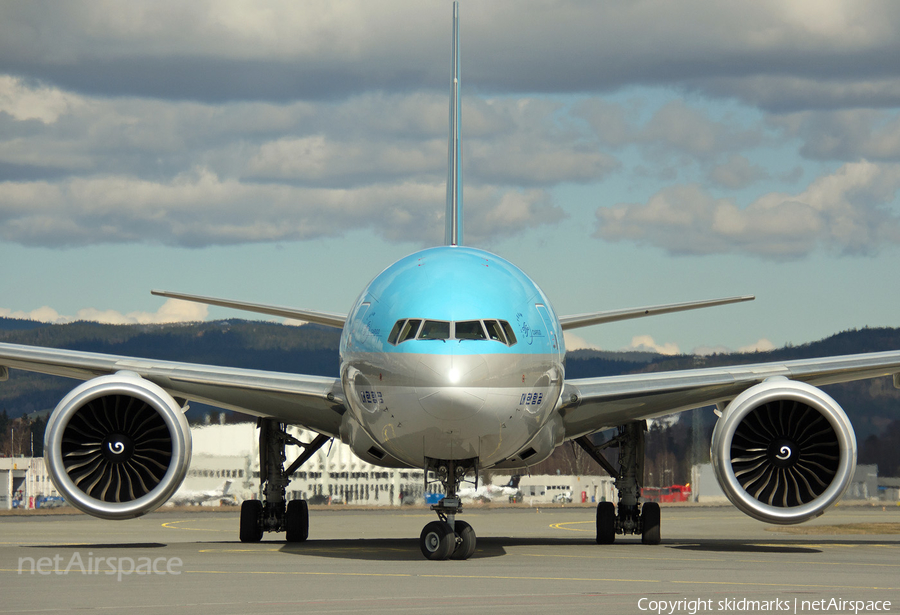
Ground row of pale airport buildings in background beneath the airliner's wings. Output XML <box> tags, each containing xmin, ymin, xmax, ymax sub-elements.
<box><xmin>0</xmin><ymin>423</ymin><xmax>900</xmax><ymax>509</ymax></box>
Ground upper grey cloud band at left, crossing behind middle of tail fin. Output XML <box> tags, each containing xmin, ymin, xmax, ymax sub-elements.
<box><xmin>0</xmin><ymin>82</ymin><xmax>618</xmax><ymax>188</ymax></box>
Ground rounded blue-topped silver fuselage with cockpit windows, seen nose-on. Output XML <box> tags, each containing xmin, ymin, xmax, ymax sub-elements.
<box><xmin>340</xmin><ymin>246</ymin><xmax>565</xmax><ymax>467</ymax></box>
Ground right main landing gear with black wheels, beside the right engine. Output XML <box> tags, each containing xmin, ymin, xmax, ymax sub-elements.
<box><xmin>575</xmin><ymin>421</ymin><xmax>660</xmax><ymax>545</ymax></box>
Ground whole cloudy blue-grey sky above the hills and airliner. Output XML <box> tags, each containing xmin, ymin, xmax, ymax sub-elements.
<box><xmin>0</xmin><ymin>0</ymin><xmax>900</xmax><ymax>353</ymax></box>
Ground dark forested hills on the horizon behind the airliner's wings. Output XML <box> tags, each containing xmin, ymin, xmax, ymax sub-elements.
<box><xmin>0</xmin><ymin>318</ymin><xmax>900</xmax><ymax>440</ymax></box>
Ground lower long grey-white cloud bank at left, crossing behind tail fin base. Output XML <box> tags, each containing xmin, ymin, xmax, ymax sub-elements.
<box><xmin>0</xmin><ymin>169</ymin><xmax>564</xmax><ymax>247</ymax></box>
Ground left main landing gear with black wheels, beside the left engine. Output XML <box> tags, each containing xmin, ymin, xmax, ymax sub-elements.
<box><xmin>240</xmin><ymin>419</ymin><xmax>330</xmax><ymax>542</ymax></box>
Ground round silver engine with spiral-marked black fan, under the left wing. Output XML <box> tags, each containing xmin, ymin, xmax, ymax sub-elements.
<box><xmin>44</xmin><ymin>372</ymin><xmax>191</xmax><ymax>519</ymax></box>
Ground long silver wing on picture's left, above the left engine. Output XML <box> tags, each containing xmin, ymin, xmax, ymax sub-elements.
<box><xmin>0</xmin><ymin>344</ymin><xmax>344</xmax><ymax>436</ymax></box>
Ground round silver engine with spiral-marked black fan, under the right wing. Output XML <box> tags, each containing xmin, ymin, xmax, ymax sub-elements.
<box><xmin>710</xmin><ymin>378</ymin><xmax>856</xmax><ymax>524</ymax></box>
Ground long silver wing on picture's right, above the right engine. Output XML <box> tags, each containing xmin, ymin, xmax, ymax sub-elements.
<box><xmin>560</xmin><ymin>351</ymin><xmax>900</xmax><ymax>438</ymax></box>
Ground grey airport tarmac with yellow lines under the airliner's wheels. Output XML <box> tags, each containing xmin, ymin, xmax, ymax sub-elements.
<box><xmin>0</xmin><ymin>505</ymin><xmax>900</xmax><ymax>615</ymax></box>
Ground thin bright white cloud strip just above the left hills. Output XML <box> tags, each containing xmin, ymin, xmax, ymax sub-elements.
<box><xmin>0</xmin><ymin>299</ymin><xmax>209</xmax><ymax>325</ymax></box>
